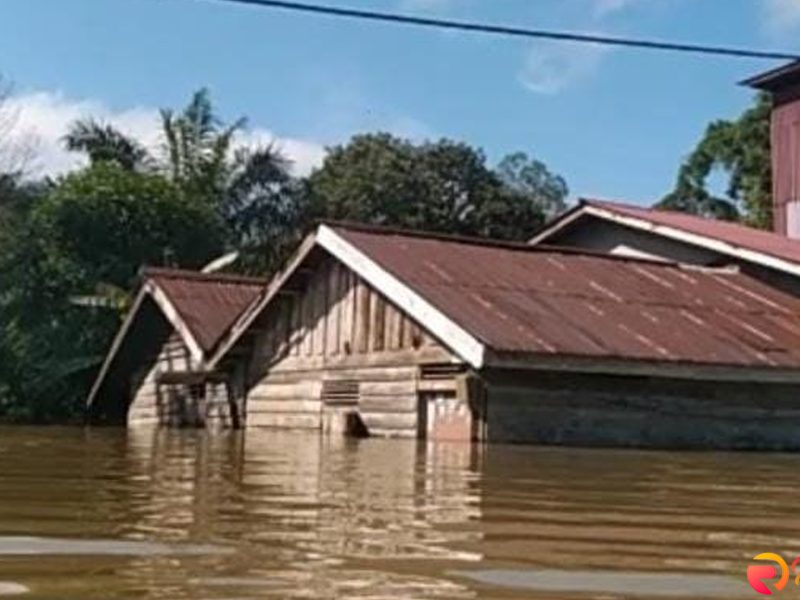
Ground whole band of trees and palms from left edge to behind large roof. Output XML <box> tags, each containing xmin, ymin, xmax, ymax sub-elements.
<box><xmin>0</xmin><ymin>91</ymin><xmax>567</xmax><ymax>422</ymax></box>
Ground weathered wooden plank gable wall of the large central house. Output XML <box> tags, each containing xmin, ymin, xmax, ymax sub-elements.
<box><xmin>247</xmin><ymin>259</ymin><xmax>462</xmax><ymax>437</ymax></box>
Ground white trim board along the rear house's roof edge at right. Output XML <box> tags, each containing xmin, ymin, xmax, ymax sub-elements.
<box><xmin>530</xmin><ymin>204</ymin><xmax>800</xmax><ymax>277</ymax></box>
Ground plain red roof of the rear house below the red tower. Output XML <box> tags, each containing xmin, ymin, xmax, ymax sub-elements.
<box><xmin>581</xmin><ymin>200</ymin><xmax>800</xmax><ymax>263</ymax></box>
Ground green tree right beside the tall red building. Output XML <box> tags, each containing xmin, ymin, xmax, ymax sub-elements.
<box><xmin>659</xmin><ymin>94</ymin><xmax>772</xmax><ymax>229</ymax></box>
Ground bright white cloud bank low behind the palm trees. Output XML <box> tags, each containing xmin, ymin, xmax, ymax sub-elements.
<box><xmin>8</xmin><ymin>92</ymin><xmax>325</xmax><ymax>176</ymax></box>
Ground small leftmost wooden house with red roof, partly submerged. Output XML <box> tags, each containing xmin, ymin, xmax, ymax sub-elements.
<box><xmin>88</xmin><ymin>268</ymin><xmax>265</xmax><ymax>427</ymax></box>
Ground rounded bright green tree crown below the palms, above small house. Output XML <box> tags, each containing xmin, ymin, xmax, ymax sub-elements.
<box><xmin>31</xmin><ymin>163</ymin><xmax>226</xmax><ymax>286</ymax></box>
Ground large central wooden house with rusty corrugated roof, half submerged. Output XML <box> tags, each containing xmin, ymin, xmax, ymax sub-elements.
<box><xmin>93</xmin><ymin>225</ymin><xmax>800</xmax><ymax>448</ymax></box>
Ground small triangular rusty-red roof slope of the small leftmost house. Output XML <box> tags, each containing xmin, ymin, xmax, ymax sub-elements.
<box><xmin>144</xmin><ymin>268</ymin><xmax>266</xmax><ymax>352</ymax></box>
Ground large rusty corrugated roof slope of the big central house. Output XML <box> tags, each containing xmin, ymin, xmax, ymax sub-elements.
<box><xmin>337</xmin><ymin>228</ymin><xmax>800</xmax><ymax>368</ymax></box>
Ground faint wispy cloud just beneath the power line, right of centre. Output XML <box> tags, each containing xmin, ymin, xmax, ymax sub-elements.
<box><xmin>519</xmin><ymin>43</ymin><xmax>609</xmax><ymax>94</ymax></box>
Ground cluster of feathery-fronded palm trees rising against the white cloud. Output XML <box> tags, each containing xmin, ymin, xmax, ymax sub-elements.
<box><xmin>64</xmin><ymin>89</ymin><xmax>297</xmax><ymax>273</ymax></box>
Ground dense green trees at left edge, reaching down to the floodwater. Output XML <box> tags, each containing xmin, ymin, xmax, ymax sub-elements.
<box><xmin>0</xmin><ymin>162</ymin><xmax>225</xmax><ymax>421</ymax></box>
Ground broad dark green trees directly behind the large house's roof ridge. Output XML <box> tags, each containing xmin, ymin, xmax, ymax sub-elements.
<box><xmin>306</xmin><ymin>133</ymin><xmax>567</xmax><ymax>240</ymax></box>
